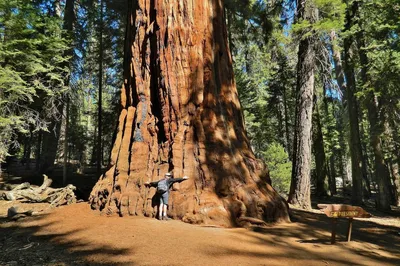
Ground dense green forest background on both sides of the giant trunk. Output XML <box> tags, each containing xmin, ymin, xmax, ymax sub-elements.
<box><xmin>0</xmin><ymin>0</ymin><xmax>400</xmax><ymax>210</ymax></box>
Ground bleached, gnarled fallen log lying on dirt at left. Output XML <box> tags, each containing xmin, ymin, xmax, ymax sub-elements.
<box><xmin>0</xmin><ymin>175</ymin><xmax>76</xmax><ymax>207</ymax></box>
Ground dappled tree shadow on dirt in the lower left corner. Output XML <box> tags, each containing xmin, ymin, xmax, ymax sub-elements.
<box><xmin>0</xmin><ymin>214</ymin><xmax>134</xmax><ymax>265</ymax></box>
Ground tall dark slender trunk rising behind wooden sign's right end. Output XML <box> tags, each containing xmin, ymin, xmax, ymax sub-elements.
<box><xmin>344</xmin><ymin>2</ymin><xmax>363</xmax><ymax>205</ymax></box>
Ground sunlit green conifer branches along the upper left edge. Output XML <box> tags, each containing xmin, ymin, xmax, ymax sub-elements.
<box><xmin>0</xmin><ymin>0</ymin><xmax>68</xmax><ymax>161</ymax></box>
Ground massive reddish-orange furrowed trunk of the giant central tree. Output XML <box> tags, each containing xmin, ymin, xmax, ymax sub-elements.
<box><xmin>89</xmin><ymin>0</ymin><xmax>288</xmax><ymax>226</ymax></box>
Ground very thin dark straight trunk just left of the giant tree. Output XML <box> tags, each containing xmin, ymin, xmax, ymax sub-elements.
<box><xmin>96</xmin><ymin>0</ymin><xmax>104</xmax><ymax>179</ymax></box>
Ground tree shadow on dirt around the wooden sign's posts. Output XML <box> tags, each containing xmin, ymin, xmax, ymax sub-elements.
<box><xmin>203</xmin><ymin>210</ymin><xmax>400</xmax><ymax>265</ymax></box>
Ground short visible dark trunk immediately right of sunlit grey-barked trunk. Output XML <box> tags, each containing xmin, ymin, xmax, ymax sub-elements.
<box><xmin>313</xmin><ymin>106</ymin><xmax>329</xmax><ymax>197</ymax></box>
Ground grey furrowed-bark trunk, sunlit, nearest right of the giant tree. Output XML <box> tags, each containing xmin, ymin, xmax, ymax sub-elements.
<box><xmin>289</xmin><ymin>0</ymin><xmax>315</xmax><ymax>209</ymax></box>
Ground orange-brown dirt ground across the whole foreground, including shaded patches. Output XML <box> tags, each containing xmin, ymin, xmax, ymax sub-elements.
<box><xmin>0</xmin><ymin>201</ymin><xmax>400</xmax><ymax>265</ymax></box>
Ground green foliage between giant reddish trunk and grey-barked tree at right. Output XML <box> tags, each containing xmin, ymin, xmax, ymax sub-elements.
<box><xmin>227</xmin><ymin>1</ymin><xmax>296</xmax><ymax>157</ymax></box>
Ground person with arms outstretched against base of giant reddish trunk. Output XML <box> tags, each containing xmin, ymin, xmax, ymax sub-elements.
<box><xmin>144</xmin><ymin>173</ymin><xmax>189</xmax><ymax>221</ymax></box>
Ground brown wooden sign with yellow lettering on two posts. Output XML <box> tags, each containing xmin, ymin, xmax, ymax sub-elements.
<box><xmin>317</xmin><ymin>204</ymin><xmax>372</xmax><ymax>244</ymax></box>
